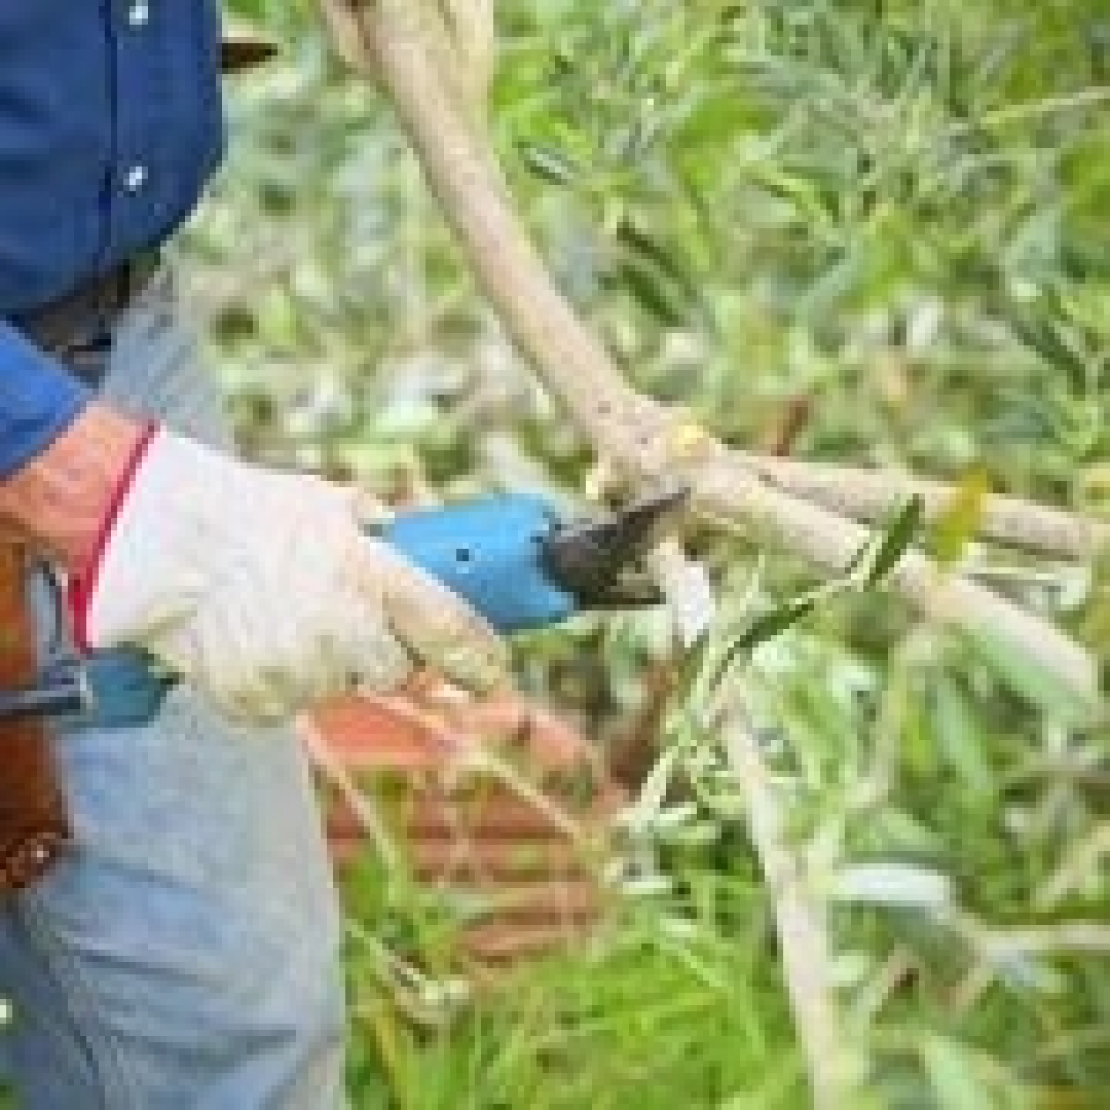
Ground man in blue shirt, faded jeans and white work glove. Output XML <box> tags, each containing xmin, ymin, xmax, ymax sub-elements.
<box><xmin>0</xmin><ymin>8</ymin><xmax>504</xmax><ymax>1110</ymax></box>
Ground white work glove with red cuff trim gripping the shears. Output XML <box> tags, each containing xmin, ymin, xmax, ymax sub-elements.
<box><xmin>70</xmin><ymin>427</ymin><xmax>506</xmax><ymax>722</ymax></box>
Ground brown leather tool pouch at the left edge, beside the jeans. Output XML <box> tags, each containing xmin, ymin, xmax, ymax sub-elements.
<box><xmin>0</xmin><ymin>542</ymin><xmax>72</xmax><ymax>897</ymax></box>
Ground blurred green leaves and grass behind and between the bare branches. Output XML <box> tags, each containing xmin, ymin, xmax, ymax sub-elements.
<box><xmin>186</xmin><ymin>0</ymin><xmax>1110</xmax><ymax>1110</ymax></box>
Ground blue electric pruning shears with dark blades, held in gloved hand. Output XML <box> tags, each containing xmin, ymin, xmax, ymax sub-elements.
<box><xmin>0</xmin><ymin>488</ymin><xmax>687</xmax><ymax>728</ymax></box>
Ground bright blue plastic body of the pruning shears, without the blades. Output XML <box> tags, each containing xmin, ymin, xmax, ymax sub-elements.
<box><xmin>30</xmin><ymin>494</ymin><xmax>578</xmax><ymax>728</ymax></box>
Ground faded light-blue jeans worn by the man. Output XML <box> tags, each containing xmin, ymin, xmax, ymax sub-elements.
<box><xmin>0</xmin><ymin>275</ymin><xmax>344</xmax><ymax>1110</ymax></box>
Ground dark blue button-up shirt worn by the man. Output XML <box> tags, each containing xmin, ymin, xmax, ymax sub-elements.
<box><xmin>0</xmin><ymin>0</ymin><xmax>223</xmax><ymax>477</ymax></box>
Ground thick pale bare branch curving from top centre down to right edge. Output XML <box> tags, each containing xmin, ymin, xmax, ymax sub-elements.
<box><xmin>321</xmin><ymin>0</ymin><xmax>1099</xmax><ymax>708</ymax></box>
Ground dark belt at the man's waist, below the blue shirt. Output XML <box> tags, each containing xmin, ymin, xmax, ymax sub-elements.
<box><xmin>11</xmin><ymin>250</ymin><xmax>161</xmax><ymax>384</ymax></box>
